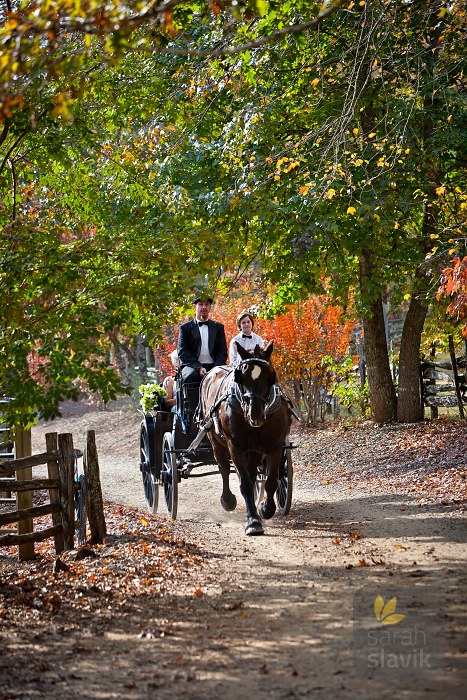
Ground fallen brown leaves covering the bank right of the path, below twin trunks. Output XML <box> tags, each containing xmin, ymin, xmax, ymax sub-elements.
<box><xmin>294</xmin><ymin>419</ymin><xmax>467</xmax><ymax>509</ymax></box>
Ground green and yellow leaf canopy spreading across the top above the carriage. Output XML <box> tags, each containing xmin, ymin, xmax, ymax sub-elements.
<box><xmin>0</xmin><ymin>0</ymin><xmax>465</xmax><ymax>420</ymax></box>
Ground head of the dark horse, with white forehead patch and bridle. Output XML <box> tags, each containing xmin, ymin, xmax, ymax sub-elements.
<box><xmin>235</xmin><ymin>340</ymin><xmax>276</xmax><ymax>428</ymax></box>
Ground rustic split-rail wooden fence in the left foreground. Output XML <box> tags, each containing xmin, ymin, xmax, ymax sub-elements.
<box><xmin>0</xmin><ymin>430</ymin><xmax>106</xmax><ymax>560</ymax></box>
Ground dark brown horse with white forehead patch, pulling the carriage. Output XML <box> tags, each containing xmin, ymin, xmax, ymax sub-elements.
<box><xmin>200</xmin><ymin>340</ymin><xmax>292</xmax><ymax>535</ymax></box>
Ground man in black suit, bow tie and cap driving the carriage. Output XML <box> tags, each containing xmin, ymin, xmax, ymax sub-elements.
<box><xmin>177</xmin><ymin>295</ymin><xmax>227</xmax><ymax>411</ymax></box>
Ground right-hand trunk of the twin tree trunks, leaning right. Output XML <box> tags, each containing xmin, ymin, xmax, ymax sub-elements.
<box><xmin>397</xmin><ymin>294</ymin><xmax>428</xmax><ymax>423</ymax></box>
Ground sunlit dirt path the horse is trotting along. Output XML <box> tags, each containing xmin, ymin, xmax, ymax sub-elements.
<box><xmin>0</xmin><ymin>408</ymin><xmax>467</xmax><ymax>700</ymax></box>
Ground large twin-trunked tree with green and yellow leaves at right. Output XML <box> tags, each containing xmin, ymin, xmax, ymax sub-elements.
<box><xmin>153</xmin><ymin>2</ymin><xmax>465</xmax><ymax>422</ymax></box>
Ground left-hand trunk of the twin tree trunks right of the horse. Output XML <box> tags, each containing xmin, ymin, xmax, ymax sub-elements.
<box><xmin>360</xmin><ymin>251</ymin><xmax>397</xmax><ymax>423</ymax></box>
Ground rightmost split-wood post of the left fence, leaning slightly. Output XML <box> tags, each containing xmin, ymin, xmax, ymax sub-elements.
<box><xmin>83</xmin><ymin>430</ymin><xmax>106</xmax><ymax>544</ymax></box>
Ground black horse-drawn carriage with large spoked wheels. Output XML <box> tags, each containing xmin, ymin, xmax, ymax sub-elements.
<box><xmin>140</xmin><ymin>344</ymin><xmax>293</xmax><ymax>534</ymax></box>
